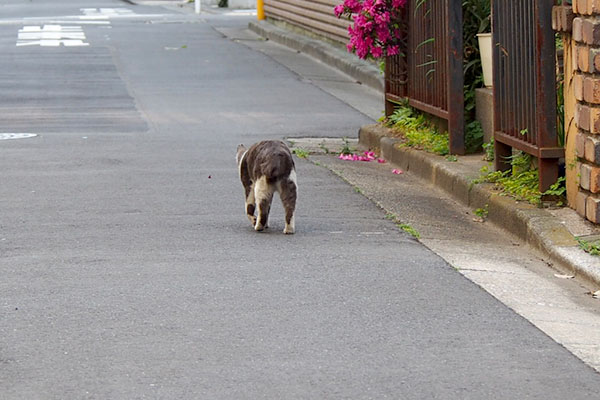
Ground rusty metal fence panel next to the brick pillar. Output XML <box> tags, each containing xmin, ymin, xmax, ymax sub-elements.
<box><xmin>492</xmin><ymin>0</ymin><xmax>564</xmax><ymax>191</ymax></box>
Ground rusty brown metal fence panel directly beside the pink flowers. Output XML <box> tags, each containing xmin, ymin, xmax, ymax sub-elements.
<box><xmin>385</xmin><ymin>0</ymin><xmax>465</xmax><ymax>154</ymax></box>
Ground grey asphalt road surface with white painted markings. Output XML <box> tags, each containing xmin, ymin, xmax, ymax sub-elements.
<box><xmin>0</xmin><ymin>0</ymin><xmax>600</xmax><ymax>400</ymax></box>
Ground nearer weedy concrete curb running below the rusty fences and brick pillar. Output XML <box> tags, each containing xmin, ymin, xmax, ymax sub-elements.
<box><xmin>359</xmin><ymin>125</ymin><xmax>600</xmax><ymax>286</ymax></box>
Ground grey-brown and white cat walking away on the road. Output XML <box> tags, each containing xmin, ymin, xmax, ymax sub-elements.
<box><xmin>236</xmin><ymin>140</ymin><xmax>298</xmax><ymax>234</ymax></box>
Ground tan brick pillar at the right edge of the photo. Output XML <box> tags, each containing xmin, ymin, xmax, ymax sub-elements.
<box><xmin>572</xmin><ymin>0</ymin><xmax>600</xmax><ymax>224</ymax></box>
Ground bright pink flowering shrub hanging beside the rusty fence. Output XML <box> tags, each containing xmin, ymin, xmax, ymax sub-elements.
<box><xmin>333</xmin><ymin>0</ymin><xmax>408</xmax><ymax>58</ymax></box>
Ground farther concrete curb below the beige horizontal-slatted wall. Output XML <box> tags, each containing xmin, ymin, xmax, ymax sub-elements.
<box><xmin>248</xmin><ymin>21</ymin><xmax>384</xmax><ymax>92</ymax></box>
